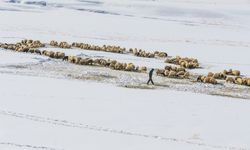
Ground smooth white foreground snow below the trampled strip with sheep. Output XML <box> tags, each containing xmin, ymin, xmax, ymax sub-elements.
<box><xmin>0</xmin><ymin>75</ymin><xmax>250</xmax><ymax>149</ymax></box>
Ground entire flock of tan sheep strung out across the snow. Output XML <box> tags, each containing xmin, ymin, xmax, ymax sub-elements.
<box><xmin>0</xmin><ymin>40</ymin><xmax>250</xmax><ymax>86</ymax></box>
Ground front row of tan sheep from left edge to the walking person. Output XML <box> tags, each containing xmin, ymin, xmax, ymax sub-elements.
<box><xmin>0</xmin><ymin>40</ymin><xmax>147</xmax><ymax>72</ymax></box>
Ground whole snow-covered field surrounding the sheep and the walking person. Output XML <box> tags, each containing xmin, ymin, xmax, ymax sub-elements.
<box><xmin>0</xmin><ymin>0</ymin><xmax>250</xmax><ymax>150</ymax></box>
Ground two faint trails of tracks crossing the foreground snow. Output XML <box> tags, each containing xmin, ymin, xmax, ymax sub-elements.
<box><xmin>0</xmin><ymin>110</ymin><xmax>248</xmax><ymax>150</ymax></box>
